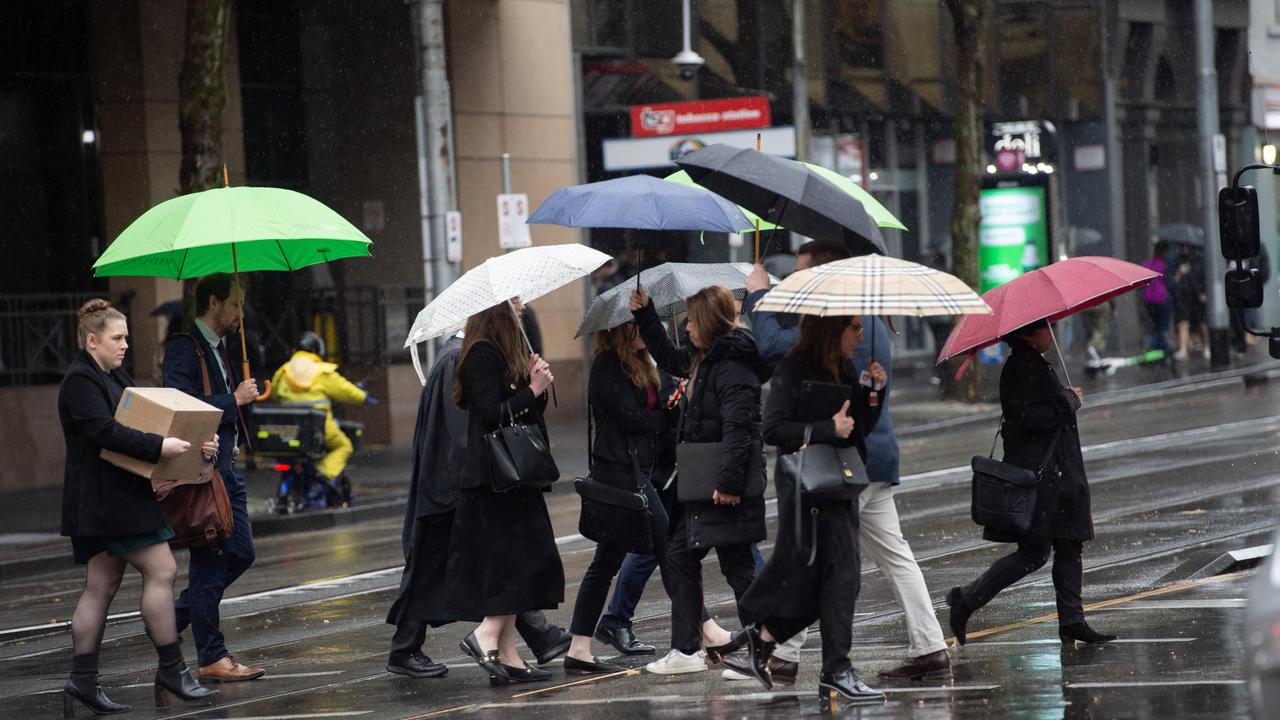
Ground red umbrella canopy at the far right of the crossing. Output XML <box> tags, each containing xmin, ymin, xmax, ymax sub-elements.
<box><xmin>938</xmin><ymin>256</ymin><xmax>1160</xmax><ymax>363</ymax></box>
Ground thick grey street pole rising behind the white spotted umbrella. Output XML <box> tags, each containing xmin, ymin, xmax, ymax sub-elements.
<box><xmin>413</xmin><ymin>0</ymin><xmax>453</xmax><ymax>365</ymax></box>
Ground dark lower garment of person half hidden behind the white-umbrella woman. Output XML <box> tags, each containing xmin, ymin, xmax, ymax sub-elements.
<box><xmin>387</xmin><ymin>510</ymin><xmax>480</xmax><ymax>628</ymax></box>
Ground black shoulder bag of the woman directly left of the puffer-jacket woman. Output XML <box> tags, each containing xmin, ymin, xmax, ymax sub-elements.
<box><xmin>573</xmin><ymin>405</ymin><xmax>654</xmax><ymax>555</ymax></box>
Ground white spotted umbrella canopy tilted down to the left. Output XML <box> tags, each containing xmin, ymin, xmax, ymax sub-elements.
<box><xmin>404</xmin><ymin>243</ymin><xmax>611</xmax><ymax>347</ymax></box>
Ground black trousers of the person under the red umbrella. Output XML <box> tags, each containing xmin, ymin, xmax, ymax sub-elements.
<box><xmin>960</xmin><ymin>539</ymin><xmax>1084</xmax><ymax>625</ymax></box>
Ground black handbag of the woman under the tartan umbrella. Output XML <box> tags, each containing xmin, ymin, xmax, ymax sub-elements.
<box><xmin>778</xmin><ymin>425</ymin><xmax>870</xmax><ymax>565</ymax></box>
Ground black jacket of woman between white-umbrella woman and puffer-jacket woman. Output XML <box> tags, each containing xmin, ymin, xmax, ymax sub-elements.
<box><xmin>586</xmin><ymin>351</ymin><xmax>671</xmax><ymax>479</ymax></box>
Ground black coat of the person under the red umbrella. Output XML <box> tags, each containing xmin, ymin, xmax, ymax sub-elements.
<box><xmin>983</xmin><ymin>340</ymin><xmax>1093</xmax><ymax>542</ymax></box>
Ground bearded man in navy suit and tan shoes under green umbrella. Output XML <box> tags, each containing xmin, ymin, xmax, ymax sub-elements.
<box><xmin>164</xmin><ymin>273</ymin><xmax>266</xmax><ymax>683</ymax></box>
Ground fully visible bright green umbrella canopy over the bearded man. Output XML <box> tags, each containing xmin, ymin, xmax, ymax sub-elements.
<box><xmin>93</xmin><ymin>187</ymin><xmax>372</xmax><ymax>279</ymax></box>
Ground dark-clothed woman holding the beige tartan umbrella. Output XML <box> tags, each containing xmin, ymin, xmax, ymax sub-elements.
<box><xmin>740</xmin><ymin>315</ymin><xmax>888</xmax><ymax>700</ymax></box>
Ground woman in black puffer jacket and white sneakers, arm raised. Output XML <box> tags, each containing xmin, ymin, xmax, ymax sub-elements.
<box><xmin>631</xmin><ymin>286</ymin><xmax>768</xmax><ymax>675</ymax></box>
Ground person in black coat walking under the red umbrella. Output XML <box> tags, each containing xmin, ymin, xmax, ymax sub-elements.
<box><xmin>947</xmin><ymin>320</ymin><xmax>1116</xmax><ymax>644</ymax></box>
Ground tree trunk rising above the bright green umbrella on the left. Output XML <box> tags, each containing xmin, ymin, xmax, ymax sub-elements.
<box><xmin>178</xmin><ymin>0</ymin><xmax>232</xmax><ymax>195</ymax></box>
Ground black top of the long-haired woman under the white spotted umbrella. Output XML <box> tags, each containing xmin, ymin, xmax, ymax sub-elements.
<box><xmin>457</xmin><ymin>341</ymin><xmax>549</xmax><ymax>489</ymax></box>
